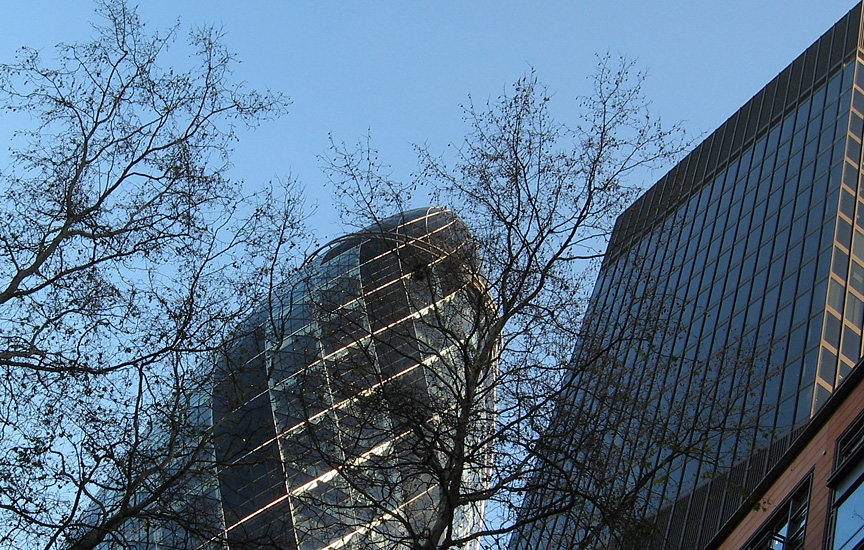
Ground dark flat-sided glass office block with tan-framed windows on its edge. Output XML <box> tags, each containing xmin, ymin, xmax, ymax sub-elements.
<box><xmin>513</xmin><ymin>5</ymin><xmax>864</xmax><ymax>550</ymax></box>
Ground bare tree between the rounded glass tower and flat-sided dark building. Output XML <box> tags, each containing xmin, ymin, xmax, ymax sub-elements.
<box><xmin>308</xmin><ymin>64</ymin><xmax>751</xmax><ymax>549</ymax></box>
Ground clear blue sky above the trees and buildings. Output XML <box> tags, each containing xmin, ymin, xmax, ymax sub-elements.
<box><xmin>0</xmin><ymin>0</ymin><xmax>853</xmax><ymax>242</ymax></box>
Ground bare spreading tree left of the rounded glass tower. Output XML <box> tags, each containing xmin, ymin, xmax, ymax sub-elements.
<box><xmin>0</xmin><ymin>0</ymin><xmax>302</xmax><ymax>549</ymax></box>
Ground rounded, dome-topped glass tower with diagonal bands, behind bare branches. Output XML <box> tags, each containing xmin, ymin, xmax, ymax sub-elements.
<box><xmin>94</xmin><ymin>208</ymin><xmax>494</xmax><ymax>550</ymax></box>
